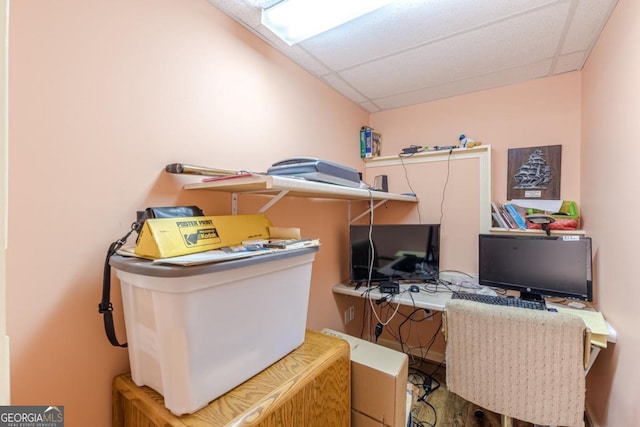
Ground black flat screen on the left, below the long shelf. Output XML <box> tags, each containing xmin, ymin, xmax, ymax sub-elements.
<box><xmin>349</xmin><ymin>224</ymin><xmax>440</xmax><ymax>284</ymax></box>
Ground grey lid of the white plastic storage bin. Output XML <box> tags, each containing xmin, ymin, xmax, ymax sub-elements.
<box><xmin>109</xmin><ymin>246</ymin><xmax>318</xmax><ymax>277</ymax></box>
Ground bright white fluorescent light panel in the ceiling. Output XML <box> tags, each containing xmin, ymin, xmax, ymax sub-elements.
<box><xmin>262</xmin><ymin>0</ymin><xmax>394</xmax><ymax>46</ymax></box>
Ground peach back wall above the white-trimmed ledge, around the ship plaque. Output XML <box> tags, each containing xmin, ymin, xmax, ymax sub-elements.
<box><xmin>370</xmin><ymin>73</ymin><xmax>580</xmax><ymax>207</ymax></box>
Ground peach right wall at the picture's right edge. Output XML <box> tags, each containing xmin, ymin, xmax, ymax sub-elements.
<box><xmin>581</xmin><ymin>0</ymin><xmax>640</xmax><ymax>426</ymax></box>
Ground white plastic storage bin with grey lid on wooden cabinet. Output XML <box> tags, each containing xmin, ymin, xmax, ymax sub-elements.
<box><xmin>111</xmin><ymin>248</ymin><xmax>317</xmax><ymax>415</ymax></box>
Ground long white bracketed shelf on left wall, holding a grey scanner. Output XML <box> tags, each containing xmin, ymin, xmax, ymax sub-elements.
<box><xmin>184</xmin><ymin>175</ymin><xmax>418</xmax><ymax>214</ymax></box>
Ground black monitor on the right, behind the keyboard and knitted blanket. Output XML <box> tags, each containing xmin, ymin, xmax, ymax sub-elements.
<box><xmin>478</xmin><ymin>234</ymin><xmax>593</xmax><ymax>301</ymax></box>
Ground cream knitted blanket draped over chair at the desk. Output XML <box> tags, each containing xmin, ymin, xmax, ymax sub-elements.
<box><xmin>446</xmin><ymin>300</ymin><xmax>585</xmax><ymax>427</ymax></box>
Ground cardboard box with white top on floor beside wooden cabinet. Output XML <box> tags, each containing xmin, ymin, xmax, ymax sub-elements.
<box><xmin>322</xmin><ymin>329</ymin><xmax>409</xmax><ymax>427</ymax></box>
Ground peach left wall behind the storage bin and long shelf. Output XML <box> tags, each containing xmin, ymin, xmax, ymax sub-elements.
<box><xmin>7</xmin><ymin>0</ymin><xmax>368</xmax><ymax>426</ymax></box>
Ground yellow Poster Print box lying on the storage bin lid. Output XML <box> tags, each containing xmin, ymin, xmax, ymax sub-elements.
<box><xmin>135</xmin><ymin>214</ymin><xmax>271</xmax><ymax>259</ymax></box>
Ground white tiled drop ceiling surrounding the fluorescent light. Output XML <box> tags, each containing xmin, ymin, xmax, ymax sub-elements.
<box><xmin>208</xmin><ymin>0</ymin><xmax>618</xmax><ymax>112</ymax></box>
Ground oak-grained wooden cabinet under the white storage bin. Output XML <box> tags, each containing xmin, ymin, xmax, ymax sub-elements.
<box><xmin>113</xmin><ymin>331</ymin><xmax>351</xmax><ymax>427</ymax></box>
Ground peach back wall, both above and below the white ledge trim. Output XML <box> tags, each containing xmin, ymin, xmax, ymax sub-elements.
<box><xmin>370</xmin><ymin>73</ymin><xmax>580</xmax><ymax>286</ymax></box>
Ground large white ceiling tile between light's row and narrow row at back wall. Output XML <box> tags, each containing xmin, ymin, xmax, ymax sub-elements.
<box><xmin>339</xmin><ymin>4</ymin><xmax>568</xmax><ymax>99</ymax></box>
